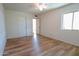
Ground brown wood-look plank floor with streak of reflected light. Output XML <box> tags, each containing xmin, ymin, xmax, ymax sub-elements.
<box><xmin>4</xmin><ymin>35</ymin><xmax>79</xmax><ymax>56</ymax></box>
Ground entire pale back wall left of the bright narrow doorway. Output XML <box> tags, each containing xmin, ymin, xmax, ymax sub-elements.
<box><xmin>5</xmin><ymin>9</ymin><xmax>32</xmax><ymax>38</ymax></box>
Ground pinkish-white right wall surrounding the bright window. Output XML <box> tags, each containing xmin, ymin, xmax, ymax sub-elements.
<box><xmin>40</xmin><ymin>4</ymin><xmax>79</xmax><ymax>46</ymax></box>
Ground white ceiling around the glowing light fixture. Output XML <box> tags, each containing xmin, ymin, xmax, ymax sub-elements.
<box><xmin>4</xmin><ymin>3</ymin><xmax>69</xmax><ymax>14</ymax></box>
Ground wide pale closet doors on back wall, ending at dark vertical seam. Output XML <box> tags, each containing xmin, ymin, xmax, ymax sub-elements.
<box><xmin>5</xmin><ymin>10</ymin><xmax>27</xmax><ymax>38</ymax></box>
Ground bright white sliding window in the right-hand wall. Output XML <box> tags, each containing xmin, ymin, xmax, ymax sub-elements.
<box><xmin>63</xmin><ymin>12</ymin><xmax>79</xmax><ymax>30</ymax></box>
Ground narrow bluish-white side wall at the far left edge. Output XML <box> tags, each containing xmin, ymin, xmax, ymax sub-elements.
<box><xmin>0</xmin><ymin>4</ymin><xmax>6</xmax><ymax>55</ymax></box>
